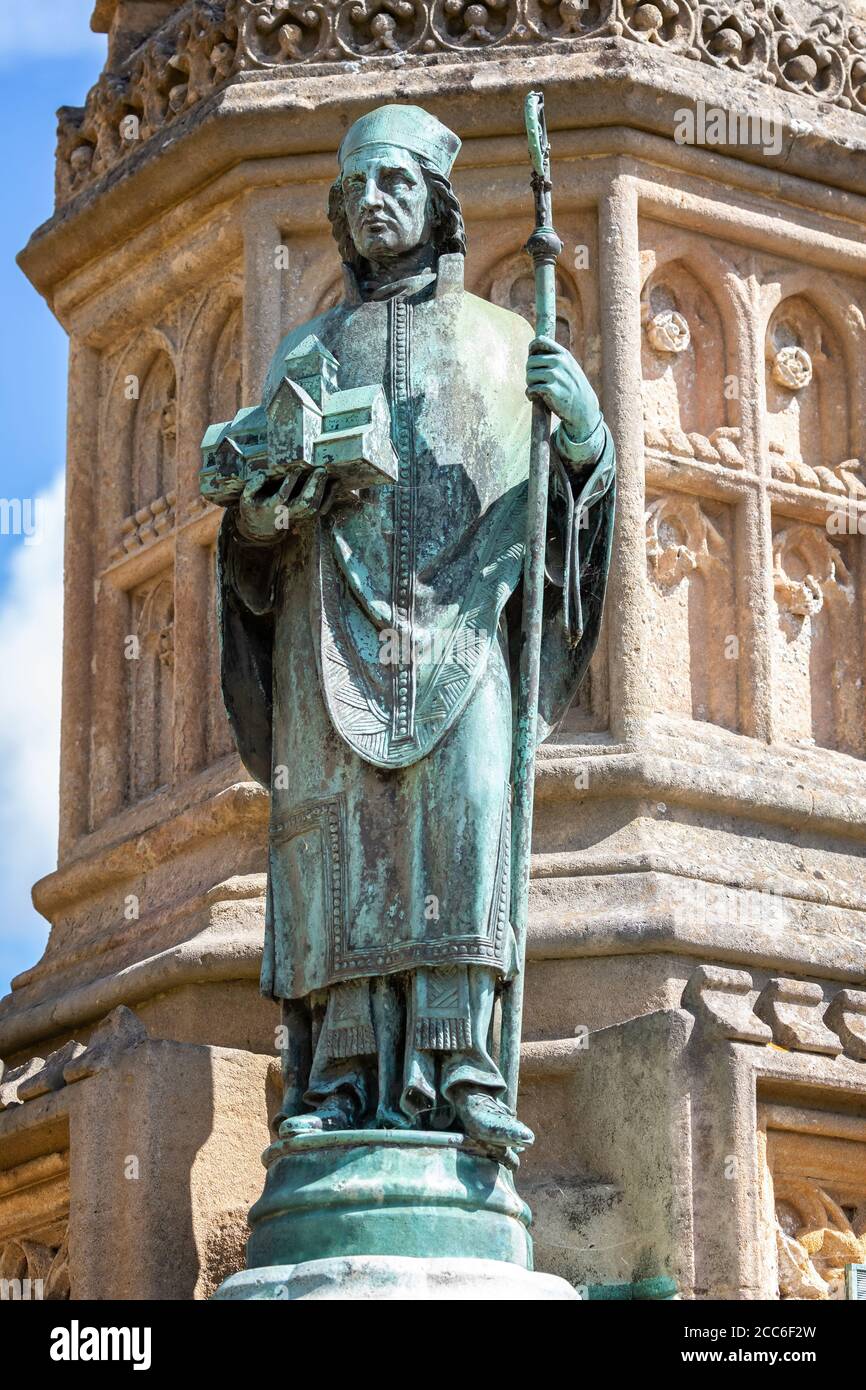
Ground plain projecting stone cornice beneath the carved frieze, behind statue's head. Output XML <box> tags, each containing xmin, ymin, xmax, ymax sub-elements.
<box><xmin>19</xmin><ymin>39</ymin><xmax>866</xmax><ymax>309</ymax></box>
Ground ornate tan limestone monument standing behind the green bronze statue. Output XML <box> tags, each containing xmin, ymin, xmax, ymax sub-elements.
<box><xmin>0</xmin><ymin>0</ymin><xmax>866</xmax><ymax>1298</ymax></box>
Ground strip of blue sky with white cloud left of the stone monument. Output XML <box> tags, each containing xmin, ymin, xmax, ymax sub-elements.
<box><xmin>0</xmin><ymin>0</ymin><xmax>106</xmax><ymax>994</ymax></box>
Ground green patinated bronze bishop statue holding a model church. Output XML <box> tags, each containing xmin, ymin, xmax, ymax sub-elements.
<box><xmin>202</xmin><ymin>106</ymin><xmax>614</xmax><ymax>1155</ymax></box>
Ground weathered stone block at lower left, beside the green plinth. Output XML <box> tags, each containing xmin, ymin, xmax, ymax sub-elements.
<box><xmin>0</xmin><ymin>1009</ymin><xmax>275</xmax><ymax>1300</ymax></box>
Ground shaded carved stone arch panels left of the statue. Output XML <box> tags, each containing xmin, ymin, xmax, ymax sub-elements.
<box><xmin>89</xmin><ymin>275</ymin><xmax>242</xmax><ymax>828</ymax></box>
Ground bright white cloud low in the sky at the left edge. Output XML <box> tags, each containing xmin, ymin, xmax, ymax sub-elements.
<box><xmin>0</xmin><ymin>474</ymin><xmax>64</xmax><ymax>994</ymax></box>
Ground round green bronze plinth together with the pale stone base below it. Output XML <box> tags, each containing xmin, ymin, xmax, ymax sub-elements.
<box><xmin>214</xmin><ymin>1130</ymin><xmax>577</xmax><ymax>1300</ymax></box>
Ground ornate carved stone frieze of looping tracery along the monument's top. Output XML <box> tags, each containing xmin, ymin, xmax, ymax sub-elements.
<box><xmin>57</xmin><ymin>0</ymin><xmax>866</xmax><ymax>204</ymax></box>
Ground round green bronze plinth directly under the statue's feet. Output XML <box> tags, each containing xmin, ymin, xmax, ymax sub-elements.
<box><xmin>240</xmin><ymin>1130</ymin><xmax>532</xmax><ymax>1270</ymax></box>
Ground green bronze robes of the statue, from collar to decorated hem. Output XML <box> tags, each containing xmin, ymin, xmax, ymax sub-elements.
<box><xmin>218</xmin><ymin>254</ymin><xmax>614</xmax><ymax>999</ymax></box>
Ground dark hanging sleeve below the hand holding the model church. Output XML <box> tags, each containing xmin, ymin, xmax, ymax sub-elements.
<box><xmin>217</xmin><ymin>507</ymin><xmax>282</xmax><ymax>787</ymax></box>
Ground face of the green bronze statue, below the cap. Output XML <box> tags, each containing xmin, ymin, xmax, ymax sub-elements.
<box><xmin>341</xmin><ymin>145</ymin><xmax>431</xmax><ymax>261</ymax></box>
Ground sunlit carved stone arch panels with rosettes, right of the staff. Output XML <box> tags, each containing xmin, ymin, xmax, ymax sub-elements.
<box><xmin>641</xmin><ymin>224</ymin><xmax>863</xmax><ymax>755</ymax></box>
